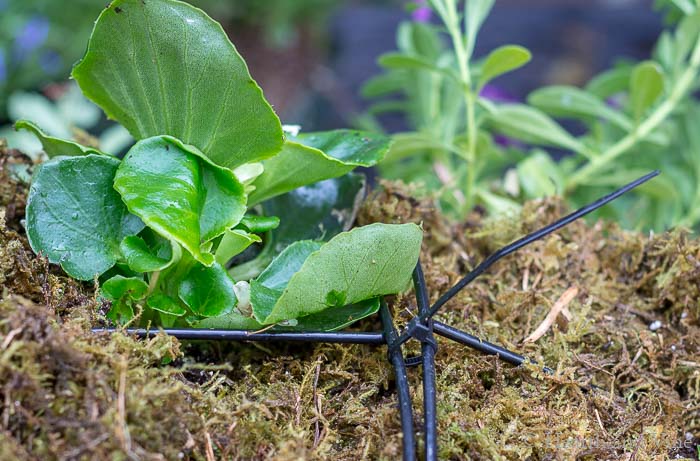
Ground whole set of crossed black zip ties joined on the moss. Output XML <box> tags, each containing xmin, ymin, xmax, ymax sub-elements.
<box><xmin>92</xmin><ymin>170</ymin><xmax>659</xmax><ymax>461</ymax></box>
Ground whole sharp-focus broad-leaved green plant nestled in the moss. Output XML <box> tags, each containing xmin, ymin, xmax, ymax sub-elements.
<box><xmin>17</xmin><ymin>0</ymin><xmax>422</xmax><ymax>330</ymax></box>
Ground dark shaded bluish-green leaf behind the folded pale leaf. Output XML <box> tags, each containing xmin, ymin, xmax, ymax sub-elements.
<box><xmin>229</xmin><ymin>173</ymin><xmax>366</xmax><ymax>280</ymax></box>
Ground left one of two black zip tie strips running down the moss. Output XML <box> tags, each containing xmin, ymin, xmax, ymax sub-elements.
<box><xmin>379</xmin><ymin>298</ymin><xmax>416</xmax><ymax>461</ymax></box>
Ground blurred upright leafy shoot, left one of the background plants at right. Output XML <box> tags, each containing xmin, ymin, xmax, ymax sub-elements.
<box><xmin>363</xmin><ymin>0</ymin><xmax>530</xmax><ymax>214</ymax></box>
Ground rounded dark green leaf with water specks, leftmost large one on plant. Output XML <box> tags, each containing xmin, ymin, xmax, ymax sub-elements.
<box><xmin>27</xmin><ymin>154</ymin><xmax>143</xmax><ymax>280</ymax></box>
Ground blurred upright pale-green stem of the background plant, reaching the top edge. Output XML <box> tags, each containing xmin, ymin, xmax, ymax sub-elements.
<box><xmin>436</xmin><ymin>0</ymin><xmax>477</xmax><ymax>211</ymax></box>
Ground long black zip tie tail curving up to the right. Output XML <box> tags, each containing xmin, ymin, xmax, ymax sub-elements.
<box><xmin>397</xmin><ymin>170</ymin><xmax>660</xmax><ymax>345</ymax></box>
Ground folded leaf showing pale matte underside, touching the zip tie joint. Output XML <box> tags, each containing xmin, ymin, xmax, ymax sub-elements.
<box><xmin>262</xmin><ymin>224</ymin><xmax>423</xmax><ymax>324</ymax></box>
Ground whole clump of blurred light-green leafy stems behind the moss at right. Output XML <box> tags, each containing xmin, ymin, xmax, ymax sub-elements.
<box><xmin>363</xmin><ymin>0</ymin><xmax>700</xmax><ymax>229</ymax></box>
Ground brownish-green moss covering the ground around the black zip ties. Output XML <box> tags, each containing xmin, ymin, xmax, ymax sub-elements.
<box><xmin>0</xmin><ymin>148</ymin><xmax>700</xmax><ymax>461</ymax></box>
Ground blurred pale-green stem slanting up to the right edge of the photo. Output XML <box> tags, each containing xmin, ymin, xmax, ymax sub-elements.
<box><xmin>566</xmin><ymin>33</ymin><xmax>700</xmax><ymax>191</ymax></box>
